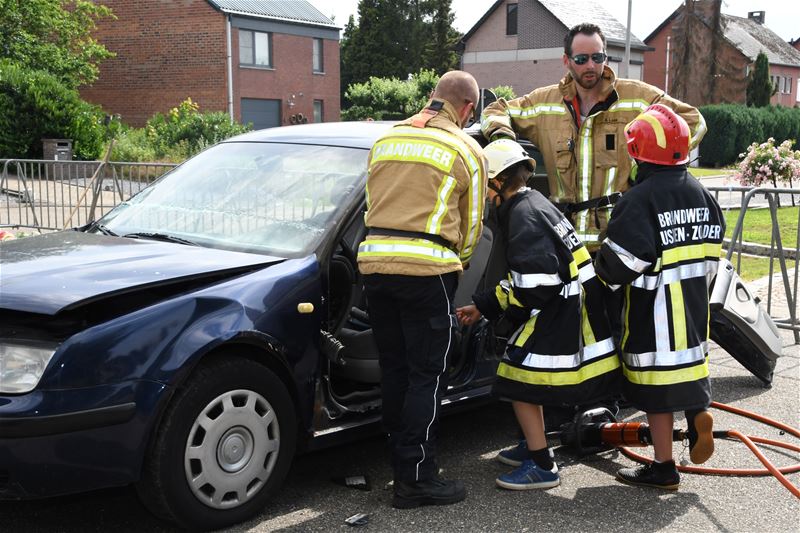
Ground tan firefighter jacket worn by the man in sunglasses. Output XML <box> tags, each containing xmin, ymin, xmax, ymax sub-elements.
<box><xmin>481</xmin><ymin>66</ymin><xmax>706</xmax><ymax>250</ymax></box>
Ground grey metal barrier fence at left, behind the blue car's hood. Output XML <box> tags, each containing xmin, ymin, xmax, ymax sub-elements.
<box><xmin>0</xmin><ymin>159</ymin><xmax>176</xmax><ymax>232</ymax></box>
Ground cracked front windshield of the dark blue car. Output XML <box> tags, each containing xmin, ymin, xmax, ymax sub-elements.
<box><xmin>95</xmin><ymin>142</ymin><xmax>368</xmax><ymax>257</ymax></box>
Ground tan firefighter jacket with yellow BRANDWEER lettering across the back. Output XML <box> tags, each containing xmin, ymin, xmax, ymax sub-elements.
<box><xmin>358</xmin><ymin>99</ymin><xmax>487</xmax><ymax>276</ymax></box>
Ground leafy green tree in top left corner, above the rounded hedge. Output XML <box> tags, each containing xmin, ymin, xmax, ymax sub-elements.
<box><xmin>0</xmin><ymin>0</ymin><xmax>114</xmax><ymax>88</ymax></box>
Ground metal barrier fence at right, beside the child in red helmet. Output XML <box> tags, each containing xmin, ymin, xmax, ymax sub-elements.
<box><xmin>708</xmin><ymin>183</ymin><xmax>800</xmax><ymax>344</ymax></box>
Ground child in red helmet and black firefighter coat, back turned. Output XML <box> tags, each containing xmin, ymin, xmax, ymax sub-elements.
<box><xmin>596</xmin><ymin>104</ymin><xmax>725</xmax><ymax>490</ymax></box>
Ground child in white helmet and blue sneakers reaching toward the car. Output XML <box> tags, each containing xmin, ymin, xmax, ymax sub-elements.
<box><xmin>456</xmin><ymin>139</ymin><xmax>620</xmax><ymax>490</ymax></box>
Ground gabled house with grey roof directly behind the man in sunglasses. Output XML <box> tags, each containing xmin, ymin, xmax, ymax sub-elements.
<box><xmin>459</xmin><ymin>0</ymin><xmax>647</xmax><ymax>95</ymax></box>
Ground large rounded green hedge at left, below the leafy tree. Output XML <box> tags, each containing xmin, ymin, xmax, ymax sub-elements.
<box><xmin>0</xmin><ymin>60</ymin><xmax>105</xmax><ymax>160</ymax></box>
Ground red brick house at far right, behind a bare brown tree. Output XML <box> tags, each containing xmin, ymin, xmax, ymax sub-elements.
<box><xmin>644</xmin><ymin>0</ymin><xmax>800</xmax><ymax>107</ymax></box>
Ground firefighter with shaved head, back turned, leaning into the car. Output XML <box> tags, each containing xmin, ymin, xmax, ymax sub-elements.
<box><xmin>358</xmin><ymin>71</ymin><xmax>487</xmax><ymax>508</ymax></box>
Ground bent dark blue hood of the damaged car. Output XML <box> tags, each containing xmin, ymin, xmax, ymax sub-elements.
<box><xmin>0</xmin><ymin>231</ymin><xmax>283</xmax><ymax>315</ymax></box>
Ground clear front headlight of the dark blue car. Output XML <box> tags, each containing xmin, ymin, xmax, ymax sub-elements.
<box><xmin>0</xmin><ymin>339</ymin><xmax>58</xmax><ymax>394</ymax></box>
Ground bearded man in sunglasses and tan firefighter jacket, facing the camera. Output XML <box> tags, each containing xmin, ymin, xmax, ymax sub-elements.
<box><xmin>481</xmin><ymin>23</ymin><xmax>706</xmax><ymax>252</ymax></box>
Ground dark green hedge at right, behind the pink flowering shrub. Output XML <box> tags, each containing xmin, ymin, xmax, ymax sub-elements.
<box><xmin>700</xmin><ymin>104</ymin><xmax>800</xmax><ymax>167</ymax></box>
